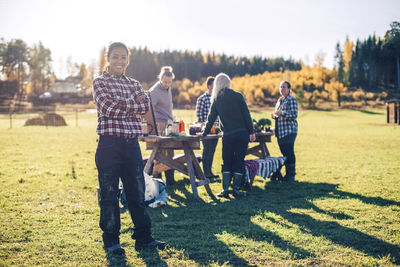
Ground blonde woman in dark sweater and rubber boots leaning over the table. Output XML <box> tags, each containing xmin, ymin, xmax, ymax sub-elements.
<box><xmin>203</xmin><ymin>73</ymin><xmax>256</xmax><ymax>198</ymax></box>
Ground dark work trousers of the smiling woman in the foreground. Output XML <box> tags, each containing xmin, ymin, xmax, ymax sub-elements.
<box><xmin>96</xmin><ymin>136</ymin><xmax>151</xmax><ymax>247</ymax></box>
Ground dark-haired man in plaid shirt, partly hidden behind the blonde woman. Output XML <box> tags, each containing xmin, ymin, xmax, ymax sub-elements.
<box><xmin>196</xmin><ymin>76</ymin><xmax>218</xmax><ymax>179</ymax></box>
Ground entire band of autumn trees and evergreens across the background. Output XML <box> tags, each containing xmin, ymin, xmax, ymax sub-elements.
<box><xmin>0</xmin><ymin>22</ymin><xmax>400</xmax><ymax>107</ymax></box>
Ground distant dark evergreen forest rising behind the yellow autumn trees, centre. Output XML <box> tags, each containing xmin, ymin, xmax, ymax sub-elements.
<box><xmin>126</xmin><ymin>48</ymin><xmax>301</xmax><ymax>82</ymax></box>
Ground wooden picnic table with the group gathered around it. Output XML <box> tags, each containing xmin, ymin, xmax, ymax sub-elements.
<box><xmin>139</xmin><ymin>132</ymin><xmax>273</xmax><ymax>199</ymax></box>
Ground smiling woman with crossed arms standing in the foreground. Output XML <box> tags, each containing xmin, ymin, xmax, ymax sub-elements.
<box><xmin>93</xmin><ymin>43</ymin><xmax>165</xmax><ymax>254</ymax></box>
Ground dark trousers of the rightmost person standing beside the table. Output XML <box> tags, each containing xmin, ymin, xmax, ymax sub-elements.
<box><xmin>278</xmin><ymin>134</ymin><xmax>297</xmax><ymax>181</ymax></box>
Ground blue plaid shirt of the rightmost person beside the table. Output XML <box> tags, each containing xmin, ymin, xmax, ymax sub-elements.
<box><xmin>275</xmin><ymin>95</ymin><xmax>297</xmax><ymax>138</ymax></box>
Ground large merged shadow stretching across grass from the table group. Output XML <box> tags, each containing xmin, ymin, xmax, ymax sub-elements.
<box><xmin>145</xmin><ymin>182</ymin><xmax>400</xmax><ymax>266</ymax></box>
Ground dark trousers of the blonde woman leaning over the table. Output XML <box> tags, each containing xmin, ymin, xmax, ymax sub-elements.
<box><xmin>222</xmin><ymin>130</ymin><xmax>250</xmax><ymax>175</ymax></box>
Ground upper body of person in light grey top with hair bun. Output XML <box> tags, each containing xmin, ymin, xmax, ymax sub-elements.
<box><xmin>149</xmin><ymin>66</ymin><xmax>175</xmax><ymax>123</ymax></box>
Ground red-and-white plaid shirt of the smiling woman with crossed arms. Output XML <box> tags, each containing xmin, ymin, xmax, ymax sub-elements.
<box><xmin>93</xmin><ymin>71</ymin><xmax>150</xmax><ymax>138</ymax></box>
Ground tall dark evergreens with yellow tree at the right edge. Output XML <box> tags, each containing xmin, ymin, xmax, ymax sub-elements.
<box><xmin>335</xmin><ymin>21</ymin><xmax>400</xmax><ymax>91</ymax></box>
